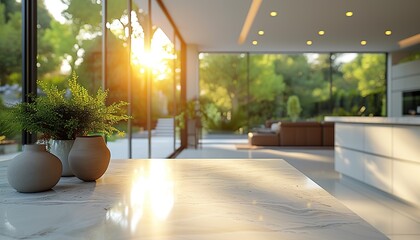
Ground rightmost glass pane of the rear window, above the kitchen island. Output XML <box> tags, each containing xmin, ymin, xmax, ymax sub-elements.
<box><xmin>332</xmin><ymin>53</ymin><xmax>386</xmax><ymax>116</ymax></box>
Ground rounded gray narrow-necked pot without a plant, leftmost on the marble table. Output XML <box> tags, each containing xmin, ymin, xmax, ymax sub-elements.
<box><xmin>7</xmin><ymin>144</ymin><xmax>62</xmax><ymax>193</ymax></box>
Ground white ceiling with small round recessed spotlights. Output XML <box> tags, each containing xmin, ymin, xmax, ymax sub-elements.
<box><xmin>162</xmin><ymin>0</ymin><xmax>420</xmax><ymax>52</ymax></box>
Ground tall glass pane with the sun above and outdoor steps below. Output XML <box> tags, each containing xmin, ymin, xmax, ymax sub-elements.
<box><xmin>148</xmin><ymin>1</ymin><xmax>175</xmax><ymax>158</ymax></box>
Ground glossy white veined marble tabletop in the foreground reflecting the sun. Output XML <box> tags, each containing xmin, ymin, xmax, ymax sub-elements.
<box><xmin>0</xmin><ymin>159</ymin><xmax>388</xmax><ymax>240</ymax></box>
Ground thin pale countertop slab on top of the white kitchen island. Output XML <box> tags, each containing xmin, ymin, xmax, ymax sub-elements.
<box><xmin>324</xmin><ymin>116</ymin><xmax>420</xmax><ymax>125</ymax></box>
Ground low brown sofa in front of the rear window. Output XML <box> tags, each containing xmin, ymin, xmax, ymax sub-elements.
<box><xmin>248</xmin><ymin>122</ymin><xmax>334</xmax><ymax>146</ymax></box>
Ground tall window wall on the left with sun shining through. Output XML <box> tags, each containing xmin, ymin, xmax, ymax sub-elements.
<box><xmin>0</xmin><ymin>0</ymin><xmax>183</xmax><ymax>159</ymax></box>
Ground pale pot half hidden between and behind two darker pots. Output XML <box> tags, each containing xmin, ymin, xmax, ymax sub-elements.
<box><xmin>49</xmin><ymin>140</ymin><xmax>74</xmax><ymax>177</ymax></box>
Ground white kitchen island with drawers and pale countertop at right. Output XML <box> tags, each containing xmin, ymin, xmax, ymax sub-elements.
<box><xmin>325</xmin><ymin>117</ymin><xmax>420</xmax><ymax>206</ymax></box>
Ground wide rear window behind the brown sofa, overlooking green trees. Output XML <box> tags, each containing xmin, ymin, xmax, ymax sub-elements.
<box><xmin>200</xmin><ymin>53</ymin><xmax>386</xmax><ymax>133</ymax></box>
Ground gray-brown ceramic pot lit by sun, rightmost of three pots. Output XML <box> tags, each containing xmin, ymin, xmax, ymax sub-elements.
<box><xmin>69</xmin><ymin>136</ymin><xmax>111</xmax><ymax>182</ymax></box>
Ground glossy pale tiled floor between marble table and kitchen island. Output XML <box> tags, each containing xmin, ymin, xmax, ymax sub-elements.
<box><xmin>178</xmin><ymin>139</ymin><xmax>420</xmax><ymax>240</ymax></box>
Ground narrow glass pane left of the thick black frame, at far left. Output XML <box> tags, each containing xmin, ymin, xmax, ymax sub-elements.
<box><xmin>0</xmin><ymin>1</ymin><xmax>22</xmax><ymax>161</ymax></box>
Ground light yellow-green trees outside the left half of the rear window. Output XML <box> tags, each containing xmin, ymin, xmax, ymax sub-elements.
<box><xmin>200</xmin><ymin>54</ymin><xmax>285</xmax><ymax>131</ymax></box>
